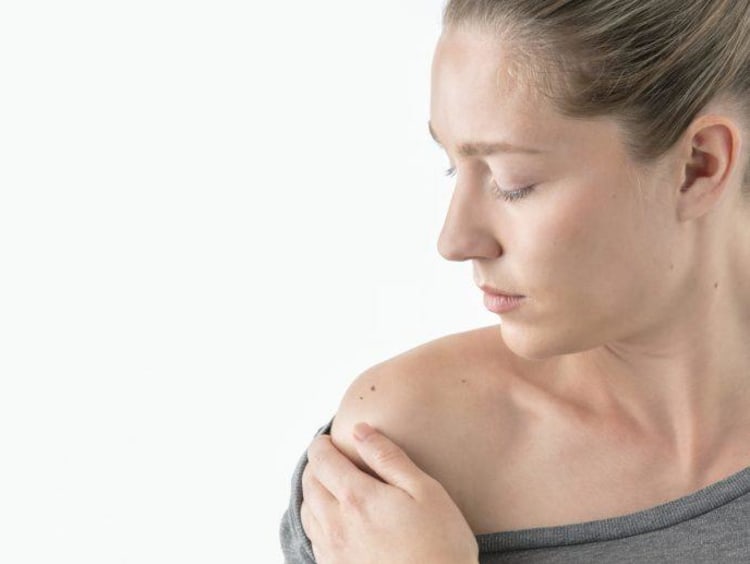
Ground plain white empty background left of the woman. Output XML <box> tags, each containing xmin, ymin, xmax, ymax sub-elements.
<box><xmin>0</xmin><ymin>0</ymin><xmax>497</xmax><ymax>564</ymax></box>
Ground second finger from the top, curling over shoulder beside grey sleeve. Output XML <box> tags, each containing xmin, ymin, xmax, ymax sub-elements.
<box><xmin>308</xmin><ymin>435</ymin><xmax>374</xmax><ymax>502</ymax></box>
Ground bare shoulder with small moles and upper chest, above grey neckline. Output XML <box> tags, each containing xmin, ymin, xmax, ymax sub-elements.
<box><xmin>331</xmin><ymin>326</ymin><xmax>728</xmax><ymax>534</ymax></box>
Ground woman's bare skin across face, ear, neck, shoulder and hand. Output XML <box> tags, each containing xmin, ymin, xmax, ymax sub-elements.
<box><xmin>303</xmin><ymin>20</ymin><xmax>750</xmax><ymax>564</ymax></box>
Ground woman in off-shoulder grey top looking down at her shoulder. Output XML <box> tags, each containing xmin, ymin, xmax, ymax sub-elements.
<box><xmin>281</xmin><ymin>0</ymin><xmax>750</xmax><ymax>564</ymax></box>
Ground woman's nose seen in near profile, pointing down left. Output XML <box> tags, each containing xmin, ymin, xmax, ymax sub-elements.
<box><xmin>437</xmin><ymin>180</ymin><xmax>502</xmax><ymax>261</ymax></box>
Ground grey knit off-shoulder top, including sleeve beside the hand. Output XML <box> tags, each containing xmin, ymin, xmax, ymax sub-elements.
<box><xmin>280</xmin><ymin>418</ymin><xmax>750</xmax><ymax>564</ymax></box>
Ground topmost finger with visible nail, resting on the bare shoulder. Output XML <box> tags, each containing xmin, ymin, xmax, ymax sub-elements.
<box><xmin>354</xmin><ymin>423</ymin><xmax>424</xmax><ymax>497</ymax></box>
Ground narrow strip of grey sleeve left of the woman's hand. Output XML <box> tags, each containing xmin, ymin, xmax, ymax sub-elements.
<box><xmin>279</xmin><ymin>418</ymin><xmax>334</xmax><ymax>564</ymax></box>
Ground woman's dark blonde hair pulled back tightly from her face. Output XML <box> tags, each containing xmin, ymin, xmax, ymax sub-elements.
<box><xmin>443</xmin><ymin>0</ymin><xmax>750</xmax><ymax>199</ymax></box>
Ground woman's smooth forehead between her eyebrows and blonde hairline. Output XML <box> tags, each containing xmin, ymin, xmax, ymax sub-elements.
<box><xmin>430</xmin><ymin>28</ymin><xmax>614</xmax><ymax>156</ymax></box>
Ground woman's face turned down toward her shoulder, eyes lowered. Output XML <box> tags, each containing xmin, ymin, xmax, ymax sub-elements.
<box><xmin>430</xmin><ymin>29</ymin><xmax>681</xmax><ymax>359</ymax></box>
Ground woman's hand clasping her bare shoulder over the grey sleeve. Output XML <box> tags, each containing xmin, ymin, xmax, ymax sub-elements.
<box><xmin>301</xmin><ymin>423</ymin><xmax>479</xmax><ymax>564</ymax></box>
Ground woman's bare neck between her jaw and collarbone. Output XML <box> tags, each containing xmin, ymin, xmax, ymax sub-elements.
<box><xmin>555</xmin><ymin>205</ymin><xmax>750</xmax><ymax>472</ymax></box>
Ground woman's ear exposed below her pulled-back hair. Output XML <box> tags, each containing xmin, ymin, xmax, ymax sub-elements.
<box><xmin>679</xmin><ymin>115</ymin><xmax>741</xmax><ymax>219</ymax></box>
